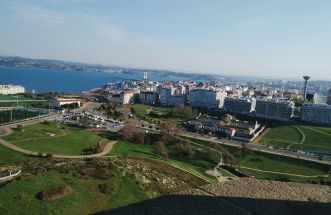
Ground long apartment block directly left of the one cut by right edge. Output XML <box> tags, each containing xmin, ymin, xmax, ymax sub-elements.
<box><xmin>255</xmin><ymin>99</ymin><xmax>295</xmax><ymax>121</ymax></box>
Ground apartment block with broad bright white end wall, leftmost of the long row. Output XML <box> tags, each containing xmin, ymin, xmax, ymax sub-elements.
<box><xmin>189</xmin><ymin>89</ymin><xmax>227</xmax><ymax>109</ymax></box>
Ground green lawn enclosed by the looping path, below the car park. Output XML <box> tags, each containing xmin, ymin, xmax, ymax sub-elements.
<box><xmin>4</xmin><ymin>123</ymin><xmax>108</xmax><ymax>155</ymax></box>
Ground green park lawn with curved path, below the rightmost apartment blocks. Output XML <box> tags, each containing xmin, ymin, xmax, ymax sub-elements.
<box><xmin>261</xmin><ymin>125</ymin><xmax>331</xmax><ymax>154</ymax></box>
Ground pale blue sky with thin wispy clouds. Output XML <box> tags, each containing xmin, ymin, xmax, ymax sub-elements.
<box><xmin>0</xmin><ymin>0</ymin><xmax>331</xmax><ymax>80</ymax></box>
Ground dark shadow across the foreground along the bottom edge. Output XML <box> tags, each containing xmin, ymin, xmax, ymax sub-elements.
<box><xmin>95</xmin><ymin>195</ymin><xmax>331</xmax><ymax>215</ymax></box>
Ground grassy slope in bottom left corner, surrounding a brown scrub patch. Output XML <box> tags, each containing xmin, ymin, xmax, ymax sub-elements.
<box><xmin>0</xmin><ymin>172</ymin><xmax>150</xmax><ymax>214</ymax></box>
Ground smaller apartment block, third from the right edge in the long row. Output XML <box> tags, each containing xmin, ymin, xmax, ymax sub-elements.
<box><xmin>223</xmin><ymin>97</ymin><xmax>256</xmax><ymax>114</ymax></box>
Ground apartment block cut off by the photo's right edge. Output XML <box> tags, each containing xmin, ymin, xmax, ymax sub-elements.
<box><xmin>301</xmin><ymin>103</ymin><xmax>331</xmax><ymax>125</ymax></box>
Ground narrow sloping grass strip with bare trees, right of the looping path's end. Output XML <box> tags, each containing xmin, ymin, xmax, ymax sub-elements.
<box><xmin>109</xmin><ymin>141</ymin><xmax>215</xmax><ymax>181</ymax></box>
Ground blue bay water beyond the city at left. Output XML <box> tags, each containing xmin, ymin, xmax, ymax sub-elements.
<box><xmin>0</xmin><ymin>66</ymin><xmax>164</xmax><ymax>93</ymax></box>
